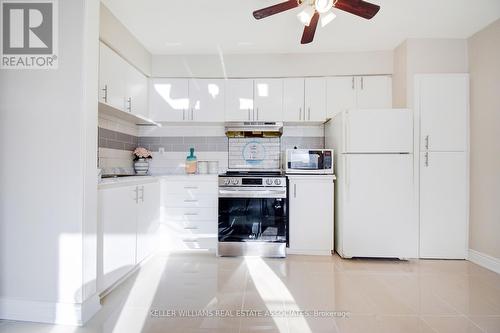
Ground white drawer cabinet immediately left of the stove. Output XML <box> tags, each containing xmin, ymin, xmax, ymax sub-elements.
<box><xmin>161</xmin><ymin>175</ymin><xmax>218</xmax><ymax>250</ymax></box>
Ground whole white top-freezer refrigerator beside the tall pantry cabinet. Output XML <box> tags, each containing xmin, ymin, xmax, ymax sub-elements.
<box><xmin>325</xmin><ymin>109</ymin><xmax>419</xmax><ymax>259</ymax></box>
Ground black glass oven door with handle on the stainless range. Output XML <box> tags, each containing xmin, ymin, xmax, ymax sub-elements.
<box><xmin>219</xmin><ymin>187</ymin><xmax>288</xmax><ymax>243</ymax></box>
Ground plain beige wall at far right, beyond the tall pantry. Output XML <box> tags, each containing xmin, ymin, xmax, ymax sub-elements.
<box><xmin>469</xmin><ymin>20</ymin><xmax>500</xmax><ymax>262</ymax></box>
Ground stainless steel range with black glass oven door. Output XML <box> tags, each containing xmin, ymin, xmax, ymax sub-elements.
<box><xmin>218</xmin><ymin>173</ymin><xmax>288</xmax><ymax>257</ymax></box>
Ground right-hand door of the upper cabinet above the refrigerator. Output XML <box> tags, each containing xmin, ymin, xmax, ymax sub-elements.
<box><xmin>357</xmin><ymin>76</ymin><xmax>392</xmax><ymax>109</ymax></box>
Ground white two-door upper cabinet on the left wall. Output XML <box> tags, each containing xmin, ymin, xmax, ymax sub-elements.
<box><xmin>99</xmin><ymin>43</ymin><xmax>149</xmax><ymax>118</ymax></box>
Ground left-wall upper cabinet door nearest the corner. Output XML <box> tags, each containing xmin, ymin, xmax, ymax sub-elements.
<box><xmin>126</xmin><ymin>65</ymin><xmax>149</xmax><ymax>118</ymax></box>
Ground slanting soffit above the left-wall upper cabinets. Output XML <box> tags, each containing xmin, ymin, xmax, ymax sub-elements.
<box><xmin>99</xmin><ymin>3</ymin><xmax>151</xmax><ymax>76</ymax></box>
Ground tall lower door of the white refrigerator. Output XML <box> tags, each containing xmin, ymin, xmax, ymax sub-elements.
<box><xmin>337</xmin><ymin>154</ymin><xmax>418</xmax><ymax>258</ymax></box>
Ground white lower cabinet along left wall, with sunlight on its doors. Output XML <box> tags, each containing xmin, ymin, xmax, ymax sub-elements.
<box><xmin>98</xmin><ymin>182</ymin><xmax>160</xmax><ymax>291</ymax></box>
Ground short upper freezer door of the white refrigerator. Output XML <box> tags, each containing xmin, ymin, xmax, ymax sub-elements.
<box><xmin>344</xmin><ymin>109</ymin><xmax>413</xmax><ymax>153</ymax></box>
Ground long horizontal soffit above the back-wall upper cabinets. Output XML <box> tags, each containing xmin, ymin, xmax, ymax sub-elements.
<box><xmin>152</xmin><ymin>51</ymin><xmax>393</xmax><ymax>78</ymax></box>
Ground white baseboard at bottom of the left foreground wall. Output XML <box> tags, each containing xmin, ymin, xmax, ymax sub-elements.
<box><xmin>0</xmin><ymin>295</ymin><xmax>101</xmax><ymax>326</ymax></box>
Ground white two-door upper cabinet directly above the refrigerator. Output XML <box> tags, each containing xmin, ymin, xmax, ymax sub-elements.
<box><xmin>327</xmin><ymin>76</ymin><xmax>392</xmax><ymax>118</ymax></box>
